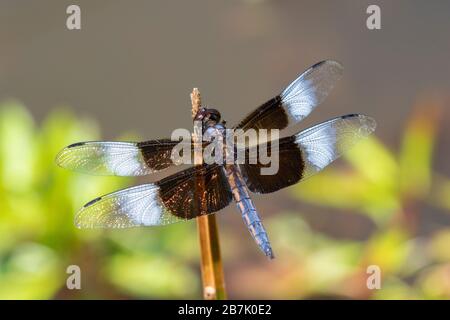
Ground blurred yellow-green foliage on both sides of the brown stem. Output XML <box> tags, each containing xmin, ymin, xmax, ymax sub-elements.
<box><xmin>0</xmin><ymin>101</ymin><xmax>450</xmax><ymax>299</ymax></box>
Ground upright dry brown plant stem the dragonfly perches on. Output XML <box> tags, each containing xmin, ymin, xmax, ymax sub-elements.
<box><xmin>191</xmin><ymin>88</ymin><xmax>227</xmax><ymax>300</ymax></box>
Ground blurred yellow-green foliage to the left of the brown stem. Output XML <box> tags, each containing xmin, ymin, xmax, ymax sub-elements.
<box><xmin>0</xmin><ymin>101</ymin><xmax>200</xmax><ymax>299</ymax></box>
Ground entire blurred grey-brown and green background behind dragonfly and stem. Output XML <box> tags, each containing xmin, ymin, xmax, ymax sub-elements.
<box><xmin>0</xmin><ymin>0</ymin><xmax>450</xmax><ymax>299</ymax></box>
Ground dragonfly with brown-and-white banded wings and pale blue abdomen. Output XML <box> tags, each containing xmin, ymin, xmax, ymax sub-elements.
<box><xmin>56</xmin><ymin>60</ymin><xmax>376</xmax><ymax>259</ymax></box>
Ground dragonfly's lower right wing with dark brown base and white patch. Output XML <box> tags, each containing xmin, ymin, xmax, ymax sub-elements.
<box><xmin>239</xmin><ymin>114</ymin><xmax>376</xmax><ymax>193</ymax></box>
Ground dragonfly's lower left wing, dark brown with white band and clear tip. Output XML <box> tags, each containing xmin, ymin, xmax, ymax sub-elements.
<box><xmin>75</xmin><ymin>165</ymin><xmax>232</xmax><ymax>228</ymax></box>
